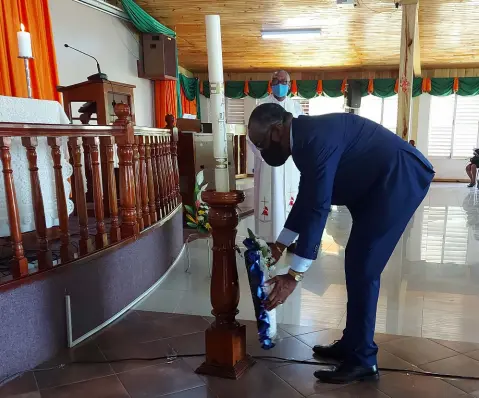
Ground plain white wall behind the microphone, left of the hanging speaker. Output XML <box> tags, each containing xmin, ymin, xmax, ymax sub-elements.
<box><xmin>49</xmin><ymin>0</ymin><xmax>154</xmax><ymax>127</ymax></box>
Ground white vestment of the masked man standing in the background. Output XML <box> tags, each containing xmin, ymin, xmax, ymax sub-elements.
<box><xmin>248</xmin><ymin>95</ymin><xmax>303</xmax><ymax>242</ymax></box>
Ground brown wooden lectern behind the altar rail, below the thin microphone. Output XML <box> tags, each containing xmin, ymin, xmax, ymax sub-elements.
<box><xmin>57</xmin><ymin>80</ymin><xmax>136</xmax><ymax>217</ymax></box>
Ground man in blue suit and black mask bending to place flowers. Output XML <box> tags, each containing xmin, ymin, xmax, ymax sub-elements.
<box><xmin>248</xmin><ymin>104</ymin><xmax>434</xmax><ymax>383</ymax></box>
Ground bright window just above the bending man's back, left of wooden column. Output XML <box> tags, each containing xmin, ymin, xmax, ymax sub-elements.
<box><xmin>359</xmin><ymin>95</ymin><xmax>398</xmax><ymax>133</ymax></box>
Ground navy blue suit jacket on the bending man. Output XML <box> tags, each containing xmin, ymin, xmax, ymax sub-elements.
<box><xmin>285</xmin><ymin>113</ymin><xmax>434</xmax><ymax>260</ymax></box>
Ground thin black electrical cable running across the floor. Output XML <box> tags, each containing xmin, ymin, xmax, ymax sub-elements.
<box><xmin>0</xmin><ymin>353</ymin><xmax>479</xmax><ymax>386</ymax></box>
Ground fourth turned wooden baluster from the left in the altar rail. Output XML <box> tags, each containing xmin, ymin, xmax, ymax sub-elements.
<box><xmin>68</xmin><ymin>137</ymin><xmax>93</xmax><ymax>255</ymax></box>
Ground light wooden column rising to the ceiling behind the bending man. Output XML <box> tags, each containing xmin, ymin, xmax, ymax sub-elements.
<box><xmin>397</xmin><ymin>0</ymin><xmax>420</xmax><ymax>141</ymax></box>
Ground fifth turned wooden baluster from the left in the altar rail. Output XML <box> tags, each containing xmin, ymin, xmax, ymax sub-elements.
<box><xmin>86</xmin><ymin>137</ymin><xmax>108</xmax><ymax>249</ymax></box>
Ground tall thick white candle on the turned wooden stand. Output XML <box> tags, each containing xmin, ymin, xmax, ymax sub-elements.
<box><xmin>205</xmin><ymin>15</ymin><xmax>229</xmax><ymax>192</ymax></box>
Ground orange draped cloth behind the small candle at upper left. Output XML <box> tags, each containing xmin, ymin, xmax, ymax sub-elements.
<box><xmin>0</xmin><ymin>0</ymin><xmax>61</xmax><ymax>101</ymax></box>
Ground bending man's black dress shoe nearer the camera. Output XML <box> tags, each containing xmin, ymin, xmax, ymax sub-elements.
<box><xmin>314</xmin><ymin>363</ymin><xmax>379</xmax><ymax>384</ymax></box>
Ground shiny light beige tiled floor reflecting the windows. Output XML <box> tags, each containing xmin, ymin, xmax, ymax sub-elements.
<box><xmin>138</xmin><ymin>184</ymin><xmax>479</xmax><ymax>343</ymax></box>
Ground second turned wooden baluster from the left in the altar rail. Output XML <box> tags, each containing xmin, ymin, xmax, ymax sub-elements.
<box><xmin>22</xmin><ymin>137</ymin><xmax>53</xmax><ymax>270</ymax></box>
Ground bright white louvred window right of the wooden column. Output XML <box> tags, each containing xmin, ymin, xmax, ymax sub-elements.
<box><xmin>428</xmin><ymin>95</ymin><xmax>479</xmax><ymax>158</ymax></box>
